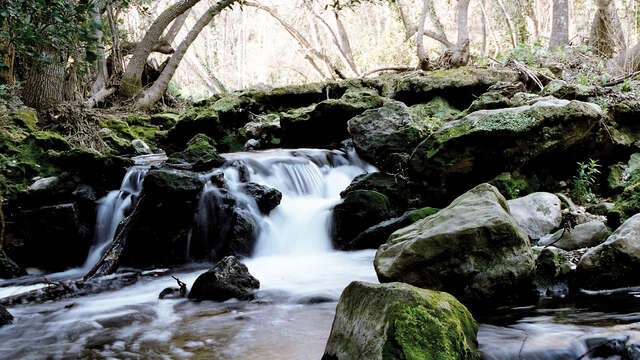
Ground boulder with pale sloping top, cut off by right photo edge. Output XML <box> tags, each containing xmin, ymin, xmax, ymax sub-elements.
<box><xmin>578</xmin><ymin>214</ymin><xmax>640</xmax><ymax>289</ymax></box>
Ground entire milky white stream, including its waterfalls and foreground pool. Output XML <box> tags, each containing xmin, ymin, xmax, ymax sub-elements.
<box><xmin>0</xmin><ymin>149</ymin><xmax>640</xmax><ymax>360</ymax></box>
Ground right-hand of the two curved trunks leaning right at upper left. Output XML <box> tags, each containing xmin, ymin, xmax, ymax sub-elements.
<box><xmin>136</xmin><ymin>0</ymin><xmax>238</xmax><ymax>108</ymax></box>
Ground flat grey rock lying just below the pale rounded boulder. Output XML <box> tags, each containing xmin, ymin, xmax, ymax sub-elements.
<box><xmin>538</xmin><ymin>220</ymin><xmax>609</xmax><ymax>251</ymax></box>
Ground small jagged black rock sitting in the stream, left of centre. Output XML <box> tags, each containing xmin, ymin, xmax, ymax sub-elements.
<box><xmin>189</xmin><ymin>256</ymin><xmax>260</xmax><ymax>301</ymax></box>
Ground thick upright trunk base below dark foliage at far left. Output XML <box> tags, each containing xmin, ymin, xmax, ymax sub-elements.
<box><xmin>22</xmin><ymin>53</ymin><xmax>65</xmax><ymax>109</ymax></box>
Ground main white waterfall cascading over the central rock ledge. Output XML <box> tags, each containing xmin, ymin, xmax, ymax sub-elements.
<box><xmin>196</xmin><ymin>149</ymin><xmax>376</xmax><ymax>257</ymax></box>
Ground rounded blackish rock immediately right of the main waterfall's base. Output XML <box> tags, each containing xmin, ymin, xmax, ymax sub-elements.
<box><xmin>333</xmin><ymin>190</ymin><xmax>391</xmax><ymax>249</ymax></box>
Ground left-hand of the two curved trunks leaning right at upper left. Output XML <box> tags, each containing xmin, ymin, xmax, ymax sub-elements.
<box><xmin>120</xmin><ymin>0</ymin><xmax>200</xmax><ymax>98</ymax></box>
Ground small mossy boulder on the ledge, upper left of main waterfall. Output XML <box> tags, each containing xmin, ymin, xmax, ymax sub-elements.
<box><xmin>167</xmin><ymin>134</ymin><xmax>226</xmax><ymax>171</ymax></box>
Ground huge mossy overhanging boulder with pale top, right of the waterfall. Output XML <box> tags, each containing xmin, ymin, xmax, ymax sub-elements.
<box><xmin>409</xmin><ymin>99</ymin><xmax>602</xmax><ymax>205</ymax></box>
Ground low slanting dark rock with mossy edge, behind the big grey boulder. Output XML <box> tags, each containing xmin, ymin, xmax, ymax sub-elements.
<box><xmin>344</xmin><ymin>207</ymin><xmax>440</xmax><ymax>250</ymax></box>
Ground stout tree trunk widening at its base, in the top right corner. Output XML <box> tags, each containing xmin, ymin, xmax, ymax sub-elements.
<box><xmin>589</xmin><ymin>0</ymin><xmax>626</xmax><ymax>58</ymax></box>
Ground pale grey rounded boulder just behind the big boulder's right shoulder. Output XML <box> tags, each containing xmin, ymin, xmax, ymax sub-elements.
<box><xmin>508</xmin><ymin>192</ymin><xmax>562</xmax><ymax>240</ymax></box>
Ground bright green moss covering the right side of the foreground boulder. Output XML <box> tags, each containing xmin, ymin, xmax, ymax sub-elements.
<box><xmin>382</xmin><ymin>292</ymin><xmax>479</xmax><ymax>360</ymax></box>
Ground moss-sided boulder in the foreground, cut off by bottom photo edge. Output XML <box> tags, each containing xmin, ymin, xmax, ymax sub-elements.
<box><xmin>322</xmin><ymin>281</ymin><xmax>480</xmax><ymax>360</ymax></box>
